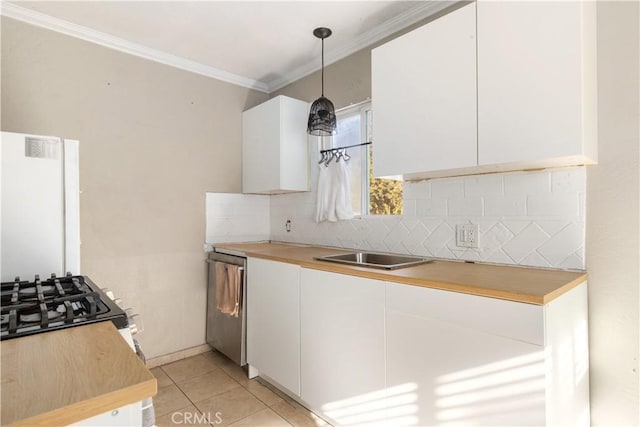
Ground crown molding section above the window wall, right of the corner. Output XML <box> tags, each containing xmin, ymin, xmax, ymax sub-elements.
<box><xmin>265</xmin><ymin>0</ymin><xmax>456</xmax><ymax>92</ymax></box>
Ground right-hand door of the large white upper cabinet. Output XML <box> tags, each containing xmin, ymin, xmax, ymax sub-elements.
<box><xmin>477</xmin><ymin>1</ymin><xmax>597</xmax><ymax>167</ymax></box>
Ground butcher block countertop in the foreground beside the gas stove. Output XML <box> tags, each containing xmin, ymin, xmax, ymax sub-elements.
<box><xmin>1</xmin><ymin>321</ymin><xmax>157</xmax><ymax>426</ymax></box>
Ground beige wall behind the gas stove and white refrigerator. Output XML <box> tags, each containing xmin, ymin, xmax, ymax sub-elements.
<box><xmin>2</xmin><ymin>17</ymin><xmax>267</xmax><ymax>357</ymax></box>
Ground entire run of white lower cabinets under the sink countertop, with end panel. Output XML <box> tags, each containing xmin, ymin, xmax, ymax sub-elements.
<box><xmin>247</xmin><ymin>258</ymin><xmax>589</xmax><ymax>426</ymax></box>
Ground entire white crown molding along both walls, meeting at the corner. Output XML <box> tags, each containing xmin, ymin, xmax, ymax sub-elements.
<box><xmin>0</xmin><ymin>0</ymin><xmax>456</xmax><ymax>93</ymax></box>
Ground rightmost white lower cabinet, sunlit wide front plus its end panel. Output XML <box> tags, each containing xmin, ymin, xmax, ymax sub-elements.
<box><xmin>385</xmin><ymin>283</ymin><xmax>589</xmax><ymax>426</ymax></box>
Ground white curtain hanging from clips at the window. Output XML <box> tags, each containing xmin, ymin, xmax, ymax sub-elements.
<box><xmin>316</xmin><ymin>158</ymin><xmax>353</xmax><ymax>222</ymax></box>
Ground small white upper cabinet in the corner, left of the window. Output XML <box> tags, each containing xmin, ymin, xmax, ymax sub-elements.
<box><xmin>242</xmin><ymin>96</ymin><xmax>309</xmax><ymax>194</ymax></box>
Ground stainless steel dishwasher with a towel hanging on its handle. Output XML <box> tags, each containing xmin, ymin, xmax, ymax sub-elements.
<box><xmin>207</xmin><ymin>252</ymin><xmax>247</xmax><ymax>366</ymax></box>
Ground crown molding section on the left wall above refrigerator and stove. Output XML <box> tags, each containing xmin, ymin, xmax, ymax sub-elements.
<box><xmin>0</xmin><ymin>2</ymin><xmax>270</xmax><ymax>93</ymax></box>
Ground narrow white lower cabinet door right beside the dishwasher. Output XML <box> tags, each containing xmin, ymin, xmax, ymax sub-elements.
<box><xmin>247</xmin><ymin>258</ymin><xmax>300</xmax><ymax>395</ymax></box>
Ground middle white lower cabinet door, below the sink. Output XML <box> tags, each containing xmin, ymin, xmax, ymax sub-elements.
<box><xmin>300</xmin><ymin>268</ymin><xmax>385</xmax><ymax>425</ymax></box>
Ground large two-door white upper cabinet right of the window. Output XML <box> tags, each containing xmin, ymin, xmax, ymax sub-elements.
<box><xmin>372</xmin><ymin>0</ymin><xmax>597</xmax><ymax>179</ymax></box>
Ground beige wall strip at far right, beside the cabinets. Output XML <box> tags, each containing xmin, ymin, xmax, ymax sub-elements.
<box><xmin>586</xmin><ymin>1</ymin><xmax>640</xmax><ymax>426</ymax></box>
